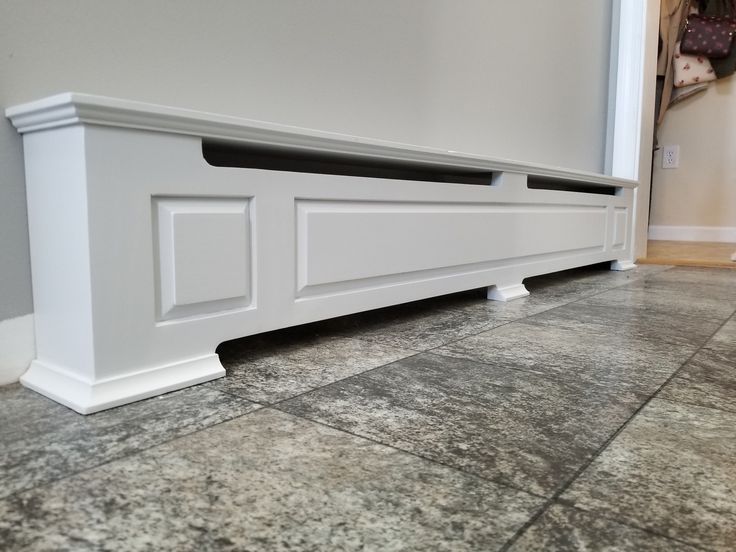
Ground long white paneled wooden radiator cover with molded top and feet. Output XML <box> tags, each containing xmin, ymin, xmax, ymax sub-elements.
<box><xmin>6</xmin><ymin>94</ymin><xmax>636</xmax><ymax>413</ymax></box>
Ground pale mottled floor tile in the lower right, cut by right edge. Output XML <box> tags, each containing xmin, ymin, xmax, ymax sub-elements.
<box><xmin>562</xmin><ymin>399</ymin><xmax>736</xmax><ymax>551</ymax></box>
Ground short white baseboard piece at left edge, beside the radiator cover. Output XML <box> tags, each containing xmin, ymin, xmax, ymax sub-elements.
<box><xmin>0</xmin><ymin>314</ymin><xmax>36</xmax><ymax>385</ymax></box>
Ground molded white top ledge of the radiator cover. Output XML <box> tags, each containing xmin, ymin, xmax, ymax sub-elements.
<box><xmin>5</xmin><ymin>92</ymin><xmax>636</xmax><ymax>188</ymax></box>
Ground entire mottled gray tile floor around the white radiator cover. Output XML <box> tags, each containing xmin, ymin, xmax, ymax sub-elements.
<box><xmin>0</xmin><ymin>266</ymin><xmax>736</xmax><ymax>552</ymax></box>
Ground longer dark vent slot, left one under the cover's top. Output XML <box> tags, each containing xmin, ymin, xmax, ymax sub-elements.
<box><xmin>202</xmin><ymin>141</ymin><xmax>492</xmax><ymax>186</ymax></box>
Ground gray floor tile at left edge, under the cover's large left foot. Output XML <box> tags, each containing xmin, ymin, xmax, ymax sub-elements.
<box><xmin>0</xmin><ymin>384</ymin><xmax>258</xmax><ymax>498</ymax></box>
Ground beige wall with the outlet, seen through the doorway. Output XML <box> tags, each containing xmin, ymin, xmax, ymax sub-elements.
<box><xmin>650</xmin><ymin>77</ymin><xmax>736</xmax><ymax>234</ymax></box>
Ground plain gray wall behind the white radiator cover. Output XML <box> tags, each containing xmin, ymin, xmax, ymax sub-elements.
<box><xmin>0</xmin><ymin>0</ymin><xmax>611</xmax><ymax>320</ymax></box>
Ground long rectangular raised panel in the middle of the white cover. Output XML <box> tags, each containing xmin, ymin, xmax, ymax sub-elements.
<box><xmin>296</xmin><ymin>200</ymin><xmax>606</xmax><ymax>295</ymax></box>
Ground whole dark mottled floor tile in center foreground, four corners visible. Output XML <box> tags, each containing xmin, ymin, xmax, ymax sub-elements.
<box><xmin>279</xmin><ymin>354</ymin><xmax>644</xmax><ymax>495</ymax></box>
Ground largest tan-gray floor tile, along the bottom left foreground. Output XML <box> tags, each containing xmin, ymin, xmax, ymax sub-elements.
<box><xmin>0</xmin><ymin>409</ymin><xmax>541</xmax><ymax>552</ymax></box>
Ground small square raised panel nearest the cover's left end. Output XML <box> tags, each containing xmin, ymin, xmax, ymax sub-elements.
<box><xmin>154</xmin><ymin>197</ymin><xmax>252</xmax><ymax>320</ymax></box>
